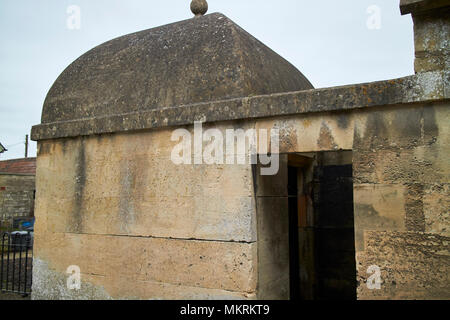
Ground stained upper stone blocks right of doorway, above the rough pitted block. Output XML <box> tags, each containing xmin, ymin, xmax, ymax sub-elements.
<box><xmin>353</xmin><ymin>103</ymin><xmax>450</xmax><ymax>255</ymax></box>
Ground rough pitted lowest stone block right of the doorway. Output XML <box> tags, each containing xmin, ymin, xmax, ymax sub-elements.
<box><xmin>357</xmin><ymin>231</ymin><xmax>450</xmax><ymax>300</ymax></box>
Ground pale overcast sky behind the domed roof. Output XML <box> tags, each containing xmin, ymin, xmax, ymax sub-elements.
<box><xmin>0</xmin><ymin>0</ymin><xmax>414</xmax><ymax>160</ymax></box>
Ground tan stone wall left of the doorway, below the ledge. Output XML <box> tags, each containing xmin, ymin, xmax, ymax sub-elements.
<box><xmin>33</xmin><ymin>123</ymin><xmax>257</xmax><ymax>299</ymax></box>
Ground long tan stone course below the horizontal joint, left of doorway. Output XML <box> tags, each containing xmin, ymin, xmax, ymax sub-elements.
<box><xmin>35</xmin><ymin>233</ymin><xmax>257</xmax><ymax>293</ymax></box>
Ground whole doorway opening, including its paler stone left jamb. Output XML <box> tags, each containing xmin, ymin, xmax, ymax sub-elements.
<box><xmin>253</xmin><ymin>151</ymin><xmax>356</xmax><ymax>300</ymax></box>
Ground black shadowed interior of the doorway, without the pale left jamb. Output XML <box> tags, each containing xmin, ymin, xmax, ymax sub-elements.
<box><xmin>288</xmin><ymin>151</ymin><xmax>356</xmax><ymax>300</ymax></box>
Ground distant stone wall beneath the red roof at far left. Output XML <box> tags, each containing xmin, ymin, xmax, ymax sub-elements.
<box><xmin>0</xmin><ymin>174</ymin><xmax>35</xmax><ymax>227</ymax></box>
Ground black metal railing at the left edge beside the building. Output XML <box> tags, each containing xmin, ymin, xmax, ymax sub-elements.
<box><xmin>0</xmin><ymin>231</ymin><xmax>33</xmax><ymax>296</ymax></box>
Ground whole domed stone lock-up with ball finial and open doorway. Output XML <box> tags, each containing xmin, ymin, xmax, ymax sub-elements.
<box><xmin>32</xmin><ymin>0</ymin><xmax>450</xmax><ymax>299</ymax></box>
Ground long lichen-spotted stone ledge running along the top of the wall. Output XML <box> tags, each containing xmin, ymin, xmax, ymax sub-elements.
<box><xmin>32</xmin><ymin>72</ymin><xmax>450</xmax><ymax>140</ymax></box>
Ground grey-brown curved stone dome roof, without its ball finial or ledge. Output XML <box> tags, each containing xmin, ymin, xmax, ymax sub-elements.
<box><xmin>42</xmin><ymin>13</ymin><xmax>313</xmax><ymax>124</ymax></box>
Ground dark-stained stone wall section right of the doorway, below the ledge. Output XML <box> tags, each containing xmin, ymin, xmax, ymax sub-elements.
<box><xmin>353</xmin><ymin>103</ymin><xmax>450</xmax><ymax>299</ymax></box>
